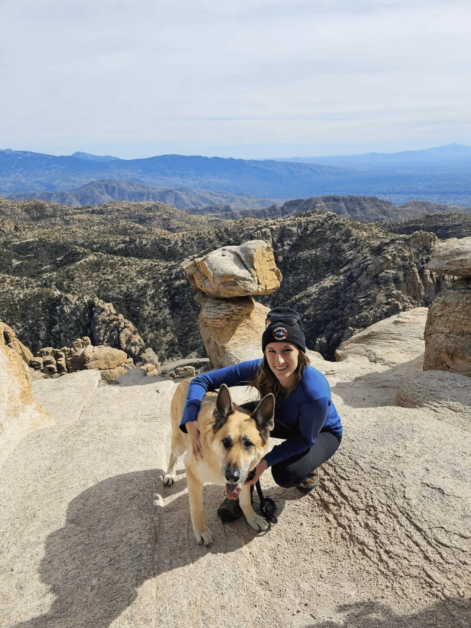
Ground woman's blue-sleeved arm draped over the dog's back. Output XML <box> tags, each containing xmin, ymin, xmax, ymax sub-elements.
<box><xmin>180</xmin><ymin>360</ymin><xmax>262</xmax><ymax>432</ymax></box>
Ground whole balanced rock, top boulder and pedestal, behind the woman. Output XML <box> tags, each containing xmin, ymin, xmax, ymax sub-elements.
<box><xmin>182</xmin><ymin>240</ymin><xmax>281</xmax><ymax>368</ymax></box>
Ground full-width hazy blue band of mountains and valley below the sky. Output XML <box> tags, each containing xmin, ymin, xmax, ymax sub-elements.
<box><xmin>0</xmin><ymin>144</ymin><xmax>471</xmax><ymax>207</ymax></box>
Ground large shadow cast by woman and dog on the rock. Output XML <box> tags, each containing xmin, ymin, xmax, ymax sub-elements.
<box><xmin>15</xmin><ymin>470</ymin><xmax>282</xmax><ymax>628</ymax></box>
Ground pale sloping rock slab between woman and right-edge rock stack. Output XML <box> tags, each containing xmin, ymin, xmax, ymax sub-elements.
<box><xmin>335</xmin><ymin>307</ymin><xmax>428</xmax><ymax>366</ymax></box>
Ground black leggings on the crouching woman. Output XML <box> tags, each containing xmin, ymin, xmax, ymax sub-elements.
<box><xmin>242</xmin><ymin>402</ymin><xmax>342</xmax><ymax>488</ymax></box>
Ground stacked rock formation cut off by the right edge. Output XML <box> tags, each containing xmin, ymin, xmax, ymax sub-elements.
<box><xmin>424</xmin><ymin>238</ymin><xmax>471</xmax><ymax>377</ymax></box>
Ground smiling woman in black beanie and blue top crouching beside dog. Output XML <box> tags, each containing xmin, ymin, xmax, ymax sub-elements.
<box><xmin>180</xmin><ymin>307</ymin><xmax>342</xmax><ymax>521</ymax></box>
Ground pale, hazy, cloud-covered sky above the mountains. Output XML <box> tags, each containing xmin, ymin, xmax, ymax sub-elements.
<box><xmin>0</xmin><ymin>0</ymin><xmax>471</xmax><ymax>159</ymax></box>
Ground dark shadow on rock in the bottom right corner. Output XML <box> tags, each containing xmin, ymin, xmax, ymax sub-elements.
<box><xmin>306</xmin><ymin>598</ymin><xmax>471</xmax><ymax>628</ymax></box>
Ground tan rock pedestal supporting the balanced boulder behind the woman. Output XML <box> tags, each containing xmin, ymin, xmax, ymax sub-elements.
<box><xmin>198</xmin><ymin>295</ymin><xmax>269</xmax><ymax>368</ymax></box>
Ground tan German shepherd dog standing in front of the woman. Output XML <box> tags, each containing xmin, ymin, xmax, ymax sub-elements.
<box><xmin>164</xmin><ymin>379</ymin><xmax>275</xmax><ymax>545</ymax></box>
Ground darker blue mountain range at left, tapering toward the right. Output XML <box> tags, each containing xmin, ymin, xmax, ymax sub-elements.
<box><xmin>0</xmin><ymin>150</ymin><xmax>354</xmax><ymax>198</ymax></box>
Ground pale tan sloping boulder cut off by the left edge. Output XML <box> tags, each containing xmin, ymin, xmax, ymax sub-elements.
<box><xmin>0</xmin><ymin>322</ymin><xmax>54</xmax><ymax>467</ymax></box>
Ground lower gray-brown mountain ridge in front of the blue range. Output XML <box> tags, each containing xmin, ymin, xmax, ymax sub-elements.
<box><xmin>7</xmin><ymin>180</ymin><xmax>276</xmax><ymax>209</ymax></box>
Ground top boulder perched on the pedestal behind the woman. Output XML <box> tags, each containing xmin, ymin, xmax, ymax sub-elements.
<box><xmin>182</xmin><ymin>240</ymin><xmax>281</xmax><ymax>299</ymax></box>
